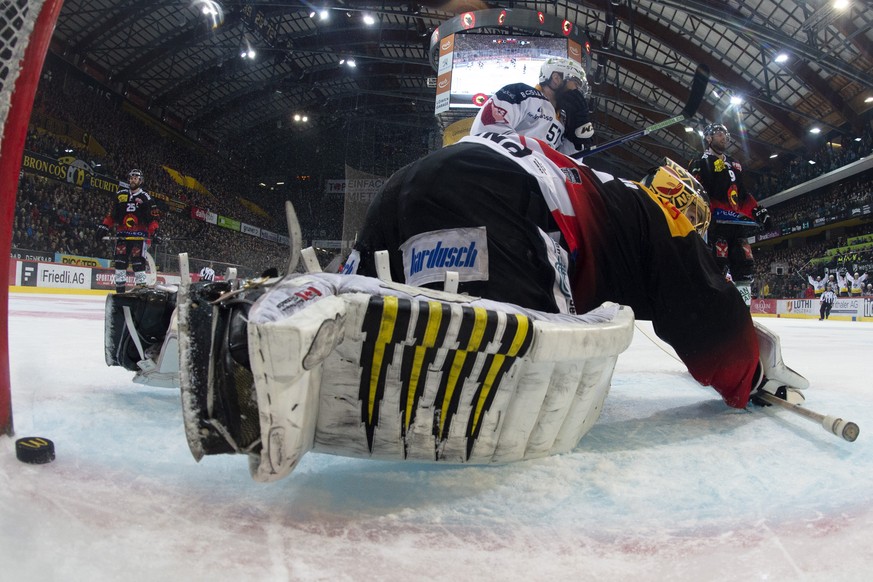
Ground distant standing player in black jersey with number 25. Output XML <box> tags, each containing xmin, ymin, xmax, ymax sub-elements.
<box><xmin>97</xmin><ymin>169</ymin><xmax>159</xmax><ymax>293</ymax></box>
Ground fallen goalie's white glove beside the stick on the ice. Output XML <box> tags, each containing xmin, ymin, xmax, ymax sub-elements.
<box><xmin>750</xmin><ymin>322</ymin><xmax>809</xmax><ymax>406</ymax></box>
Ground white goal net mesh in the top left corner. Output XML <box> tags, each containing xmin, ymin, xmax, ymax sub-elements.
<box><xmin>0</xmin><ymin>0</ymin><xmax>44</xmax><ymax>155</ymax></box>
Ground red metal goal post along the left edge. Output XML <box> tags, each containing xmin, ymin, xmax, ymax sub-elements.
<box><xmin>0</xmin><ymin>0</ymin><xmax>63</xmax><ymax>436</ymax></box>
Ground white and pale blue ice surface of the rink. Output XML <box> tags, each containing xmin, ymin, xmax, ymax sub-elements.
<box><xmin>0</xmin><ymin>294</ymin><xmax>873</xmax><ymax>582</ymax></box>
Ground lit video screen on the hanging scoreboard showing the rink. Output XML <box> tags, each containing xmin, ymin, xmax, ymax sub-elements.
<box><xmin>449</xmin><ymin>34</ymin><xmax>567</xmax><ymax>109</ymax></box>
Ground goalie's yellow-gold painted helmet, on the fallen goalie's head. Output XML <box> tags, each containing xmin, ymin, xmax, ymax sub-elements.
<box><xmin>642</xmin><ymin>158</ymin><xmax>712</xmax><ymax>236</ymax></box>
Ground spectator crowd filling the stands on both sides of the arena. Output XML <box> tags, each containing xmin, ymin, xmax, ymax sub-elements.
<box><xmin>12</xmin><ymin>59</ymin><xmax>873</xmax><ymax>288</ymax></box>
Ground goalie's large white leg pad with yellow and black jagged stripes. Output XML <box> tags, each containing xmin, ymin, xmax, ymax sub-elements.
<box><xmin>248</xmin><ymin>273</ymin><xmax>633</xmax><ymax>481</ymax></box>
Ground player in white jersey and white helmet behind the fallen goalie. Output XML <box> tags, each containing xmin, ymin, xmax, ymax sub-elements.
<box><xmin>470</xmin><ymin>57</ymin><xmax>594</xmax><ymax>155</ymax></box>
